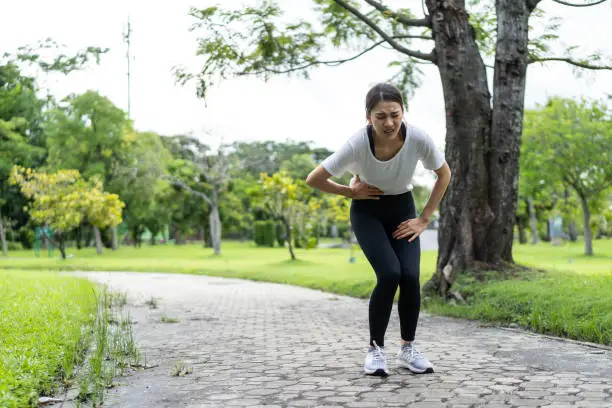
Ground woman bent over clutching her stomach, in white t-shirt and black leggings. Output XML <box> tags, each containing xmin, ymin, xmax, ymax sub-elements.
<box><xmin>306</xmin><ymin>84</ymin><xmax>450</xmax><ymax>376</ymax></box>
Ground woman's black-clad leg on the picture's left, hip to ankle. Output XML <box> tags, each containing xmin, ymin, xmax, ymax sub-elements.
<box><xmin>351</xmin><ymin>201</ymin><xmax>401</xmax><ymax>347</ymax></box>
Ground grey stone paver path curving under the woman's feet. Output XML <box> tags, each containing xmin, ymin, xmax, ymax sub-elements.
<box><xmin>79</xmin><ymin>273</ymin><xmax>612</xmax><ymax>408</ymax></box>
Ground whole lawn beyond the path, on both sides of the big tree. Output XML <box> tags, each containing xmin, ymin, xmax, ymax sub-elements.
<box><xmin>0</xmin><ymin>240</ymin><xmax>612</xmax><ymax>344</ymax></box>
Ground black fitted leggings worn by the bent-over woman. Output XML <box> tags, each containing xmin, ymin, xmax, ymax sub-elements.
<box><xmin>351</xmin><ymin>192</ymin><xmax>421</xmax><ymax>347</ymax></box>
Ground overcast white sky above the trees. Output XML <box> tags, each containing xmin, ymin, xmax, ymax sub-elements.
<box><xmin>0</xmin><ymin>0</ymin><xmax>612</xmax><ymax>154</ymax></box>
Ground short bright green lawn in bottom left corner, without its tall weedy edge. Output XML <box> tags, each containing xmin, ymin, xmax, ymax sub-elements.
<box><xmin>0</xmin><ymin>270</ymin><xmax>96</xmax><ymax>408</ymax></box>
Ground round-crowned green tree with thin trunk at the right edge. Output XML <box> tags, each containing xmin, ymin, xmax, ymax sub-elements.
<box><xmin>525</xmin><ymin>98</ymin><xmax>612</xmax><ymax>255</ymax></box>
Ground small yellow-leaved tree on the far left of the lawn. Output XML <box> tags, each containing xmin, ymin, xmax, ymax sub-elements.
<box><xmin>10</xmin><ymin>166</ymin><xmax>124</xmax><ymax>259</ymax></box>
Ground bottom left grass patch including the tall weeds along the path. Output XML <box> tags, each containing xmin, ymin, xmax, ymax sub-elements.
<box><xmin>0</xmin><ymin>270</ymin><xmax>138</xmax><ymax>408</ymax></box>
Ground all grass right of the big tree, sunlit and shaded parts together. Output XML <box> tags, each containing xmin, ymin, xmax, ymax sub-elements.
<box><xmin>425</xmin><ymin>240</ymin><xmax>612</xmax><ymax>345</ymax></box>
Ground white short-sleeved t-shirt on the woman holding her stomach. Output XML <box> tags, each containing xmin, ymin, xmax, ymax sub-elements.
<box><xmin>321</xmin><ymin>123</ymin><xmax>444</xmax><ymax>195</ymax></box>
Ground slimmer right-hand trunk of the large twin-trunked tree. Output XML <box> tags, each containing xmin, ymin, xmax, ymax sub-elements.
<box><xmin>486</xmin><ymin>0</ymin><xmax>537</xmax><ymax>264</ymax></box>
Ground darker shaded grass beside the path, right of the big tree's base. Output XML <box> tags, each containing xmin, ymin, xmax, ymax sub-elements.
<box><xmin>426</xmin><ymin>271</ymin><xmax>612</xmax><ymax>345</ymax></box>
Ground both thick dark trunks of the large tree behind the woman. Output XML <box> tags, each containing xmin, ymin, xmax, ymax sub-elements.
<box><xmin>424</xmin><ymin>0</ymin><xmax>536</xmax><ymax>298</ymax></box>
